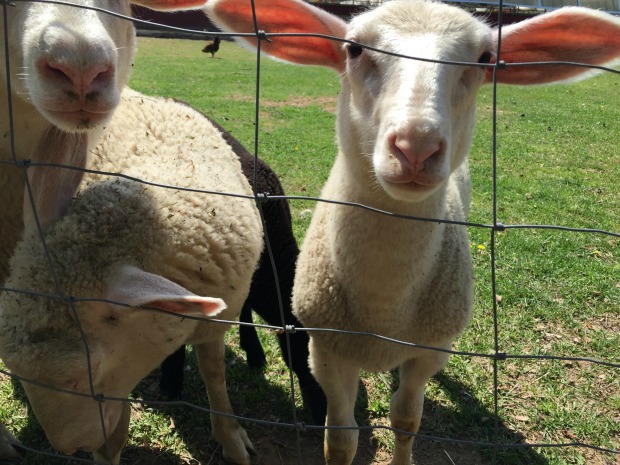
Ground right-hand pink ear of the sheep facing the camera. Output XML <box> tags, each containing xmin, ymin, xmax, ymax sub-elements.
<box><xmin>486</xmin><ymin>7</ymin><xmax>620</xmax><ymax>84</ymax></box>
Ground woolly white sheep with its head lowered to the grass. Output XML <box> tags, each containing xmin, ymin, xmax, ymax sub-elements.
<box><xmin>0</xmin><ymin>89</ymin><xmax>263</xmax><ymax>465</ymax></box>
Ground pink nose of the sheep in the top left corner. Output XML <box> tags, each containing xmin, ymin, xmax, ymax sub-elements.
<box><xmin>38</xmin><ymin>59</ymin><xmax>114</xmax><ymax>100</ymax></box>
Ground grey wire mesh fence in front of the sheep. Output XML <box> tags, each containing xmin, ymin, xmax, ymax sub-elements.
<box><xmin>0</xmin><ymin>0</ymin><xmax>620</xmax><ymax>463</ymax></box>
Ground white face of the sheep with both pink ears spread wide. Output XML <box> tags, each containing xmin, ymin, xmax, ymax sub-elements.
<box><xmin>338</xmin><ymin>1</ymin><xmax>493</xmax><ymax>202</ymax></box>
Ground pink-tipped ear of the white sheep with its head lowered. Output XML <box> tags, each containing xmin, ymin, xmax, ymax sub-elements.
<box><xmin>106</xmin><ymin>266</ymin><xmax>226</xmax><ymax>317</ymax></box>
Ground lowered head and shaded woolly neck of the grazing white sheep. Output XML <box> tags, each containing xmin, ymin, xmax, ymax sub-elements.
<box><xmin>0</xmin><ymin>176</ymin><xmax>226</xmax><ymax>457</ymax></box>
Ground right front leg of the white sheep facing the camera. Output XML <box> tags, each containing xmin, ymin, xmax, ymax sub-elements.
<box><xmin>390</xmin><ymin>350</ymin><xmax>448</xmax><ymax>465</ymax></box>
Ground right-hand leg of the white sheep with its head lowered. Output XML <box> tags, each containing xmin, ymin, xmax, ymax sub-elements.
<box><xmin>195</xmin><ymin>338</ymin><xmax>254</xmax><ymax>465</ymax></box>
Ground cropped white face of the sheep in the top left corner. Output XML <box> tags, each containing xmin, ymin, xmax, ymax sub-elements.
<box><xmin>0</xmin><ymin>0</ymin><xmax>135</xmax><ymax>131</ymax></box>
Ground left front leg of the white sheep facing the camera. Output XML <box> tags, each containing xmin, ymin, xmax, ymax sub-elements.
<box><xmin>310</xmin><ymin>336</ymin><xmax>360</xmax><ymax>465</ymax></box>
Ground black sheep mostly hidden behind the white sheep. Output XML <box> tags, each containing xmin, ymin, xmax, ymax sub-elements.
<box><xmin>159</xmin><ymin>112</ymin><xmax>327</xmax><ymax>424</ymax></box>
